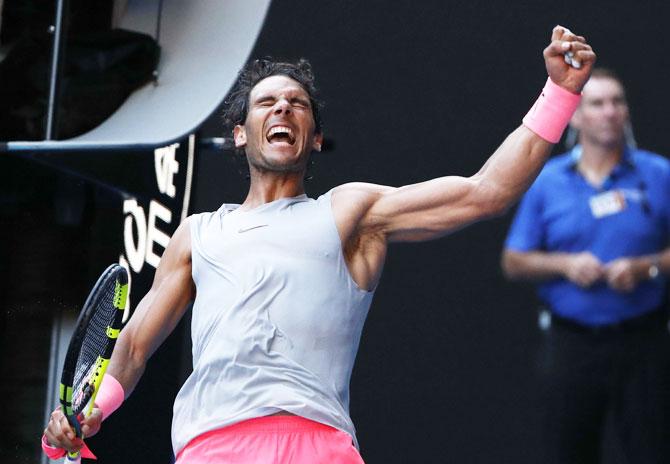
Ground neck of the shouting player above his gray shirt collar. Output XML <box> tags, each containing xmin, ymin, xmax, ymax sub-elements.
<box><xmin>241</xmin><ymin>168</ymin><xmax>305</xmax><ymax>209</ymax></box>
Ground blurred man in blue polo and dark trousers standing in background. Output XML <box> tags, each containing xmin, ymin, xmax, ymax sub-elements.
<box><xmin>503</xmin><ymin>69</ymin><xmax>670</xmax><ymax>464</ymax></box>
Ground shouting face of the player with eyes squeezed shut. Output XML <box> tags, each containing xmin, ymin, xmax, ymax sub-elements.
<box><xmin>233</xmin><ymin>75</ymin><xmax>322</xmax><ymax>172</ymax></box>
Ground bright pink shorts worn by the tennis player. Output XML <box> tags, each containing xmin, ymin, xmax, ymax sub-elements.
<box><xmin>176</xmin><ymin>416</ymin><xmax>364</xmax><ymax>464</ymax></box>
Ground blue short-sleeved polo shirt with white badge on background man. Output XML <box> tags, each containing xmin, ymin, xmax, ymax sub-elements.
<box><xmin>505</xmin><ymin>145</ymin><xmax>670</xmax><ymax>326</ymax></box>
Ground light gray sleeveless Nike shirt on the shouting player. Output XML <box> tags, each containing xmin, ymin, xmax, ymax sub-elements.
<box><xmin>172</xmin><ymin>192</ymin><xmax>372</xmax><ymax>454</ymax></box>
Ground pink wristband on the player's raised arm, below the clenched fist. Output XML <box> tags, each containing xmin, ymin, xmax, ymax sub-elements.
<box><xmin>523</xmin><ymin>78</ymin><xmax>582</xmax><ymax>143</ymax></box>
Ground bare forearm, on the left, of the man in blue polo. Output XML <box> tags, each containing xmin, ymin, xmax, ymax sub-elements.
<box><xmin>501</xmin><ymin>250</ymin><xmax>570</xmax><ymax>282</ymax></box>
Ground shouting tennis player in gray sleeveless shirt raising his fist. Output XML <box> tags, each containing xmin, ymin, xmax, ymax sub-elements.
<box><xmin>43</xmin><ymin>26</ymin><xmax>595</xmax><ymax>464</ymax></box>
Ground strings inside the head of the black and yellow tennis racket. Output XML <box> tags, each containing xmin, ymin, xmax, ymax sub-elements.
<box><xmin>72</xmin><ymin>279</ymin><xmax>117</xmax><ymax>414</ymax></box>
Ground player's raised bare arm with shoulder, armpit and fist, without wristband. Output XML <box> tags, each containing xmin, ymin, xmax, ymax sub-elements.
<box><xmin>332</xmin><ymin>26</ymin><xmax>595</xmax><ymax>289</ymax></box>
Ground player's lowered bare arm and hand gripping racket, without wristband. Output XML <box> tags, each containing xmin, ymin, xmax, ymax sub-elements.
<box><xmin>44</xmin><ymin>219</ymin><xmax>195</xmax><ymax>450</ymax></box>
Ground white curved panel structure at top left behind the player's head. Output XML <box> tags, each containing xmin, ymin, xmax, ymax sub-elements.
<box><xmin>4</xmin><ymin>0</ymin><xmax>270</xmax><ymax>151</ymax></box>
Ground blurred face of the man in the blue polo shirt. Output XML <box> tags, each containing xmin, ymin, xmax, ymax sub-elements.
<box><xmin>572</xmin><ymin>77</ymin><xmax>629</xmax><ymax>148</ymax></box>
